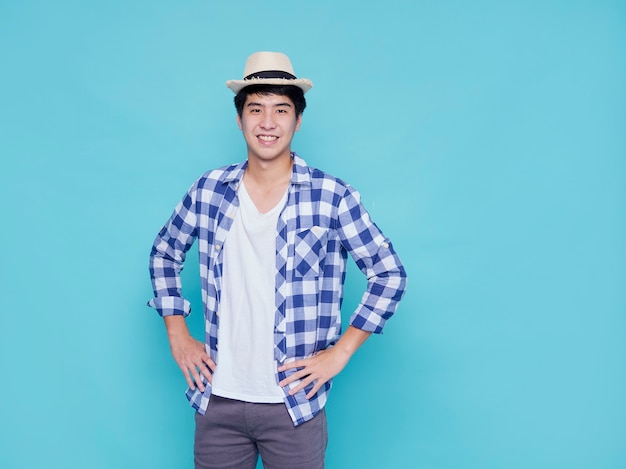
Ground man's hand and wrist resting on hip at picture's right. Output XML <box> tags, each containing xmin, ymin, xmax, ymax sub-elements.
<box><xmin>278</xmin><ymin>326</ymin><xmax>370</xmax><ymax>399</ymax></box>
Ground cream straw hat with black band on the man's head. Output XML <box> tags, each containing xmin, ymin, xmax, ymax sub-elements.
<box><xmin>226</xmin><ymin>52</ymin><xmax>313</xmax><ymax>94</ymax></box>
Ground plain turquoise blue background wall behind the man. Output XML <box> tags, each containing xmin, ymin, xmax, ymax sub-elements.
<box><xmin>0</xmin><ymin>0</ymin><xmax>626</xmax><ymax>469</ymax></box>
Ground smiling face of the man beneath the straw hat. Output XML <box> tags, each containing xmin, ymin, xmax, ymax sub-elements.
<box><xmin>237</xmin><ymin>94</ymin><xmax>302</xmax><ymax>162</ymax></box>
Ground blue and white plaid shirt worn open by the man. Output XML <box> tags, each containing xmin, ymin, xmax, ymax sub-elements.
<box><xmin>148</xmin><ymin>153</ymin><xmax>406</xmax><ymax>425</ymax></box>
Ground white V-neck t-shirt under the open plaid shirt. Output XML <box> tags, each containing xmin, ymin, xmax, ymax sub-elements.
<box><xmin>212</xmin><ymin>182</ymin><xmax>287</xmax><ymax>403</ymax></box>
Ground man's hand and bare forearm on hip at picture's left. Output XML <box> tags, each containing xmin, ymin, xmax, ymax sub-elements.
<box><xmin>164</xmin><ymin>316</ymin><xmax>215</xmax><ymax>392</ymax></box>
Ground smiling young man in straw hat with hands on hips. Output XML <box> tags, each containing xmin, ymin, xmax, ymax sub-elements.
<box><xmin>149</xmin><ymin>52</ymin><xmax>406</xmax><ymax>469</ymax></box>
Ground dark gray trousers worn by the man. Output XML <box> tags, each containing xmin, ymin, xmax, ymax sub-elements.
<box><xmin>194</xmin><ymin>395</ymin><xmax>328</xmax><ymax>469</ymax></box>
